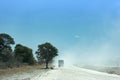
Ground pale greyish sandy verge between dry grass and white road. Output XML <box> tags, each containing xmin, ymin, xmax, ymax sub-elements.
<box><xmin>0</xmin><ymin>69</ymin><xmax>48</xmax><ymax>80</ymax></box>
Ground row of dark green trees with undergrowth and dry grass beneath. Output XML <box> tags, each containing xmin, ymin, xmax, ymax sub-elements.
<box><xmin>0</xmin><ymin>33</ymin><xmax>58</xmax><ymax>74</ymax></box>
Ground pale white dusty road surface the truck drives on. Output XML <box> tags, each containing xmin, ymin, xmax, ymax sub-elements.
<box><xmin>33</xmin><ymin>66</ymin><xmax>120</xmax><ymax>80</ymax></box>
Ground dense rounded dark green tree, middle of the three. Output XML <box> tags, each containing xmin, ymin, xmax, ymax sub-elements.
<box><xmin>14</xmin><ymin>44</ymin><xmax>35</xmax><ymax>65</ymax></box>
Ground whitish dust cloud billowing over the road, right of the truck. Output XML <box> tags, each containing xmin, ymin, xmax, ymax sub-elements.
<box><xmin>59</xmin><ymin>24</ymin><xmax>120</xmax><ymax>66</ymax></box>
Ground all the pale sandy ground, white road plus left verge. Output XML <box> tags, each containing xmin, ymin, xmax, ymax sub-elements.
<box><xmin>0</xmin><ymin>66</ymin><xmax>120</xmax><ymax>80</ymax></box>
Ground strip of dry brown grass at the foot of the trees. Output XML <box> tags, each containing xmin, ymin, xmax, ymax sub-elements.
<box><xmin>0</xmin><ymin>65</ymin><xmax>44</xmax><ymax>75</ymax></box>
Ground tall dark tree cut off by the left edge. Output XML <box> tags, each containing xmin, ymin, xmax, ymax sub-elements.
<box><xmin>0</xmin><ymin>33</ymin><xmax>15</xmax><ymax>62</ymax></box>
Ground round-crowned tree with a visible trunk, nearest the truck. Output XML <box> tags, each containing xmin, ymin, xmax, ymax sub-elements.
<box><xmin>36</xmin><ymin>42</ymin><xmax>58</xmax><ymax>68</ymax></box>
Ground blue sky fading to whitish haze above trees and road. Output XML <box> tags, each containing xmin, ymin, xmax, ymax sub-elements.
<box><xmin>0</xmin><ymin>0</ymin><xmax>120</xmax><ymax>64</ymax></box>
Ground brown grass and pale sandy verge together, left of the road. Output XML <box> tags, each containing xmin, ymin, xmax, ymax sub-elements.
<box><xmin>0</xmin><ymin>65</ymin><xmax>48</xmax><ymax>80</ymax></box>
